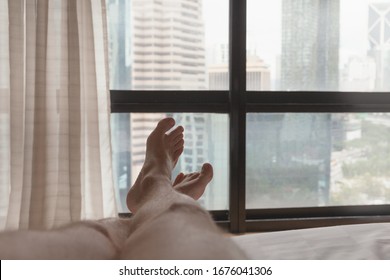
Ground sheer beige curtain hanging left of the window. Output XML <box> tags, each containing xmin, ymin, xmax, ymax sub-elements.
<box><xmin>0</xmin><ymin>0</ymin><xmax>116</xmax><ymax>229</ymax></box>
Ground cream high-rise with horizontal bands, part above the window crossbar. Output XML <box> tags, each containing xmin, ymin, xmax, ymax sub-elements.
<box><xmin>131</xmin><ymin>0</ymin><xmax>206</xmax><ymax>90</ymax></box>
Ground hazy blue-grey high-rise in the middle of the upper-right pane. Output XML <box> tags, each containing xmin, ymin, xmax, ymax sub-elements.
<box><xmin>281</xmin><ymin>0</ymin><xmax>340</xmax><ymax>91</ymax></box>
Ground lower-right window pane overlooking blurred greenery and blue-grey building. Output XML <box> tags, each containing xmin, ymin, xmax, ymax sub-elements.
<box><xmin>246</xmin><ymin>113</ymin><xmax>390</xmax><ymax>208</ymax></box>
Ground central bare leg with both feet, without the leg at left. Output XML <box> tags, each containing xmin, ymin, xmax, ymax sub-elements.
<box><xmin>121</xmin><ymin>119</ymin><xmax>245</xmax><ymax>259</ymax></box>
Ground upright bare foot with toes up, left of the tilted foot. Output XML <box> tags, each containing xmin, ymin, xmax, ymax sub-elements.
<box><xmin>126</xmin><ymin>118</ymin><xmax>184</xmax><ymax>213</ymax></box>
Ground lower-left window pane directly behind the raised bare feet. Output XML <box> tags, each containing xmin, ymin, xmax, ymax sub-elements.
<box><xmin>111</xmin><ymin>113</ymin><xmax>229</xmax><ymax>212</ymax></box>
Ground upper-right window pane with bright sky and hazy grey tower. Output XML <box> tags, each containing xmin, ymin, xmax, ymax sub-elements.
<box><xmin>247</xmin><ymin>0</ymin><xmax>390</xmax><ymax>91</ymax></box>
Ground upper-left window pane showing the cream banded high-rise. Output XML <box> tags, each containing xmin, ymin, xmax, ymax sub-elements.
<box><xmin>106</xmin><ymin>0</ymin><xmax>229</xmax><ymax>90</ymax></box>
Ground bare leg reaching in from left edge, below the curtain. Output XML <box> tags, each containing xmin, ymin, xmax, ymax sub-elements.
<box><xmin>0</xmin><ymin>218</ymin><xmax>131</xmax><ymax>260</ymax></box>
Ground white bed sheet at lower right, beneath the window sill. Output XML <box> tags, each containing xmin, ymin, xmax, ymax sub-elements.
<box><xmin>233</xmin><ymin>223</ymin><xmax>390</xmax><ymax>260</ymax></box>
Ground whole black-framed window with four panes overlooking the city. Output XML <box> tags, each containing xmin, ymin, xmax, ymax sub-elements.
<box><xmin>107</xmin><ymin>0</ymin><xmax>390</xmax><ymax>232</ymax></box>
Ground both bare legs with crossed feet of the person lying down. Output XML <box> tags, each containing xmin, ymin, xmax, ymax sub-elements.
<box><xmin>0</xmin><ymin>119</ymin><xmax>245</xmax><ymax>259</ymax></box>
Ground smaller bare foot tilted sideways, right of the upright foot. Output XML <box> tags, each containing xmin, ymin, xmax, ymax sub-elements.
<box><xmin>173</xmin><ymin>163</ymin><xmax>213</xmax><ymax>200</ymax></box>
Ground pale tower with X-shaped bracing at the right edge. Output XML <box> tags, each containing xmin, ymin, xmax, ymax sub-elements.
<box><xmin>368</xmin><ymin>1</ymin><xmax>390</xmax><ymax>91</ymax></box>
